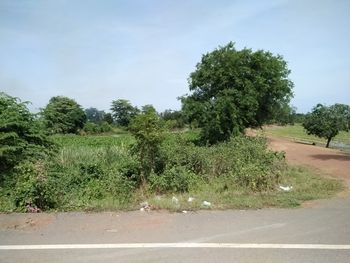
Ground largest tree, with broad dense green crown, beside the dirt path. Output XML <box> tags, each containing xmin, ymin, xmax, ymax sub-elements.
<box><xmin>182</xmin><ymin>42</ymin><xmax>293</xmax><ymax>144</ymax></box>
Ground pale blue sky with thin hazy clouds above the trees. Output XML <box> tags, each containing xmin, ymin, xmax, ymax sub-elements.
<box><xmin>0</xmin><ymin>0</ymin><xmax>350</xmax><ymax>113</ymax></box>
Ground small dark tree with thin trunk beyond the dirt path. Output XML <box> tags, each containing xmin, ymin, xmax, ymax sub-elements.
<box><xmin>303</xmin><ymin>104</ymin><xmax>350</xmax><ymax>148</ymax></box>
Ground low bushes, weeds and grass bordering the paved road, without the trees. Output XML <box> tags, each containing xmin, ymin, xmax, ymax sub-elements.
<box><xmin>0</xmin><ymin>132</ymin><xmax>341</xmax><ymax>212</ymax></box>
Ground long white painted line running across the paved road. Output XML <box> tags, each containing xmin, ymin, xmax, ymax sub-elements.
<box><xmin>0</xmin><ymin>243</ymin><xmax>350</xmax><ymax>250</ymax></box>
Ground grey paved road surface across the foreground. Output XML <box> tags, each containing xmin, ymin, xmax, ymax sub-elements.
<box><xmin>0</xmin><ymin>198</ymin><xmax>350</xmax><ymax>263</ymax></box>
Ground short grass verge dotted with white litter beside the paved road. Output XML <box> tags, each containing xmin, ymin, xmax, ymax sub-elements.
<box><xmin>141</xmin><ymin>167</ymin><xmax>343</xmax><ymax>211</ymax></box>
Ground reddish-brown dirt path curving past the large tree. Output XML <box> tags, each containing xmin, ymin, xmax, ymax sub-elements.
<box><xmin>268</xmin><ymin>137</ymin><xmax>350</xmax><ymax>187</ymax></box>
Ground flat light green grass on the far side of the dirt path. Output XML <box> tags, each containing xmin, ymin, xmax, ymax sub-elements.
<box><xmin>263</xmin><ymin>124</ymin><xmax>350</xmax><ymax>144</ymax></box>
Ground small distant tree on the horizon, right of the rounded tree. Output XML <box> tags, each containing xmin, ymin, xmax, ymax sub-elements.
<box><xmin>111</xmin><ymin>99</ymin><xmax>139</xmax><ymax>127</ymax></box>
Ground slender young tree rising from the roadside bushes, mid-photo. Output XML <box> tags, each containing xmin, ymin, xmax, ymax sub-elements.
<box><xmin>129</xmin><ymin>106</ymin><xmax>164</xmax><ymax>186</ymax></box>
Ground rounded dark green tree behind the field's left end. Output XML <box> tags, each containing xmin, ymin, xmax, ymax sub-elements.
<box><xmin>42</xmin><ymin>96</ymin><xmax>86</xmax><ymax>134</ymax></box>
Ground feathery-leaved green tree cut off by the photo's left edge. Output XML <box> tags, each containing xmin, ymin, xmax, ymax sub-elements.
<box><xmin>0</xmin><ymin>93</ymin><xmax>53</xmax><ymax>175</ymax></box>
